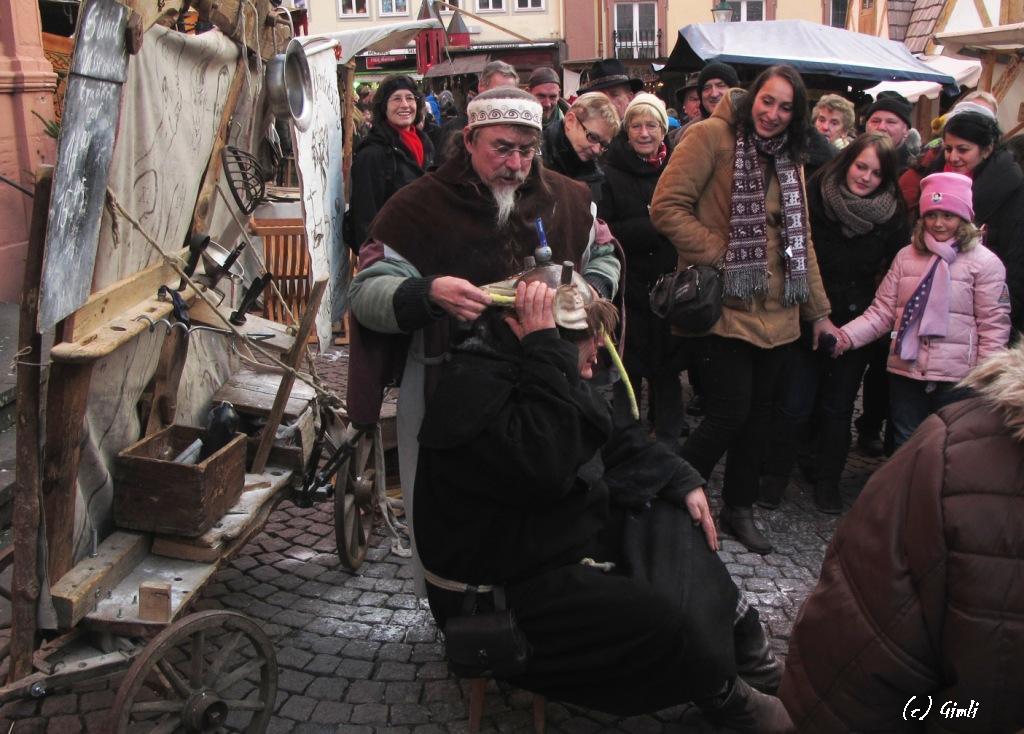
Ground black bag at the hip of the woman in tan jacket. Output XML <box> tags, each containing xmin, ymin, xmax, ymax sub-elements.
<box><xmin>649</xmin><ymin>265</ymin><xmax>722</xmax><ymax>336</ymax></box>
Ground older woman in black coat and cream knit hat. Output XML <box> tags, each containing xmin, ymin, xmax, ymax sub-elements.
<box><xmin>597</xmin><ymin>94</ymin><xmax>685</xmax><ymax>447</ymax></box>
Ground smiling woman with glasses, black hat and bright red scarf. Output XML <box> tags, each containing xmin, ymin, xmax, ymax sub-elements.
<box><xmin>348</xmin><ymin>74</ymin><xmax>434</xmax><ymax>251</ymax></box>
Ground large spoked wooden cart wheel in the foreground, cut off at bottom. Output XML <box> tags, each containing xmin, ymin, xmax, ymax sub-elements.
<box><xmin>111</xmin><ymin>609</ymin><xmax>278</xmax><ymax>734</ymax></box>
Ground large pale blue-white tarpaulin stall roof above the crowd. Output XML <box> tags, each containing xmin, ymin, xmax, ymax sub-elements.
<box><xmin>666</xmin><ymin>20</ymin><xmax>955</xmax><ymax>87</ymax></box>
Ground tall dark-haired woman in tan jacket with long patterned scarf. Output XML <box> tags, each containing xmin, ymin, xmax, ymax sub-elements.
<box><xmin>651</xmin><ymin>66</ymin><xmax>836</xmax><ymax>554</ymax></box>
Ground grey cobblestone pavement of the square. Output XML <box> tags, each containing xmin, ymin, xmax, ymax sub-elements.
<box><xmin>0</xmin><ymin>350</ymin><xmax>879</xmax><ymax>734</ymax></box>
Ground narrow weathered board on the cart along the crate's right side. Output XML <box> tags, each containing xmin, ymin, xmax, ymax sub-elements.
<box><xmin>153</xmin><ymin>467</ymin><xmax>293</xmax><ymax>562</ymax></box>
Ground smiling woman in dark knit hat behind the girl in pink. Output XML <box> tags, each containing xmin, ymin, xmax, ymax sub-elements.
<box><xmin>900</xmin><ymin>112</ymin><xmax>1024</xmax><ymax>331</ymax></box>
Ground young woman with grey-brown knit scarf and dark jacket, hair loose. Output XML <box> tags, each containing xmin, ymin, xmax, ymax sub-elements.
<box><xmin>758</xmin><ymin>133</ymin><xmax>910</xmax><ymax>514</ymax></box>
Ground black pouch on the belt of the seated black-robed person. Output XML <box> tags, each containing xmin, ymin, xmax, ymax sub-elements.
<box><xmin>444</xmin><ymin>587</ymin><xmax>530</xmax><ymax>679</ymax></box>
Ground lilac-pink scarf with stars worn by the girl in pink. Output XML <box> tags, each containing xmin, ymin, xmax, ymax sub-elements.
<box><xmin>896</xmin><ymin>232</ymin><xmax>959</xmax><ymax>361</ymax></box>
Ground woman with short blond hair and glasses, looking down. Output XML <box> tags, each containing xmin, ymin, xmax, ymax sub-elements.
<box><xmin>542</xmin><ymin>92</ymin><xmax>620</xmax><ymax>202</ymax></box>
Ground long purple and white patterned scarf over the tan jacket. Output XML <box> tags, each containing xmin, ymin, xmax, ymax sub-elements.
<box><xmin>725</xmin><ymin>128</ymin><xmax>810</xmax><ymax>306</ymax></box>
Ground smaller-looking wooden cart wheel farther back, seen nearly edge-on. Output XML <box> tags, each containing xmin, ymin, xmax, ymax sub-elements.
<box><xmin>334</xmin><ymin>427</ymin><xmax>384</xmax><ymax>571</ymax></box>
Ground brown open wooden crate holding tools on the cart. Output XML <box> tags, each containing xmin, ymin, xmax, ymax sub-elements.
<box><xmin>114</xmin><ymin>426</ymin><xmax>246</xmax><ymax>537</ymax></box>
